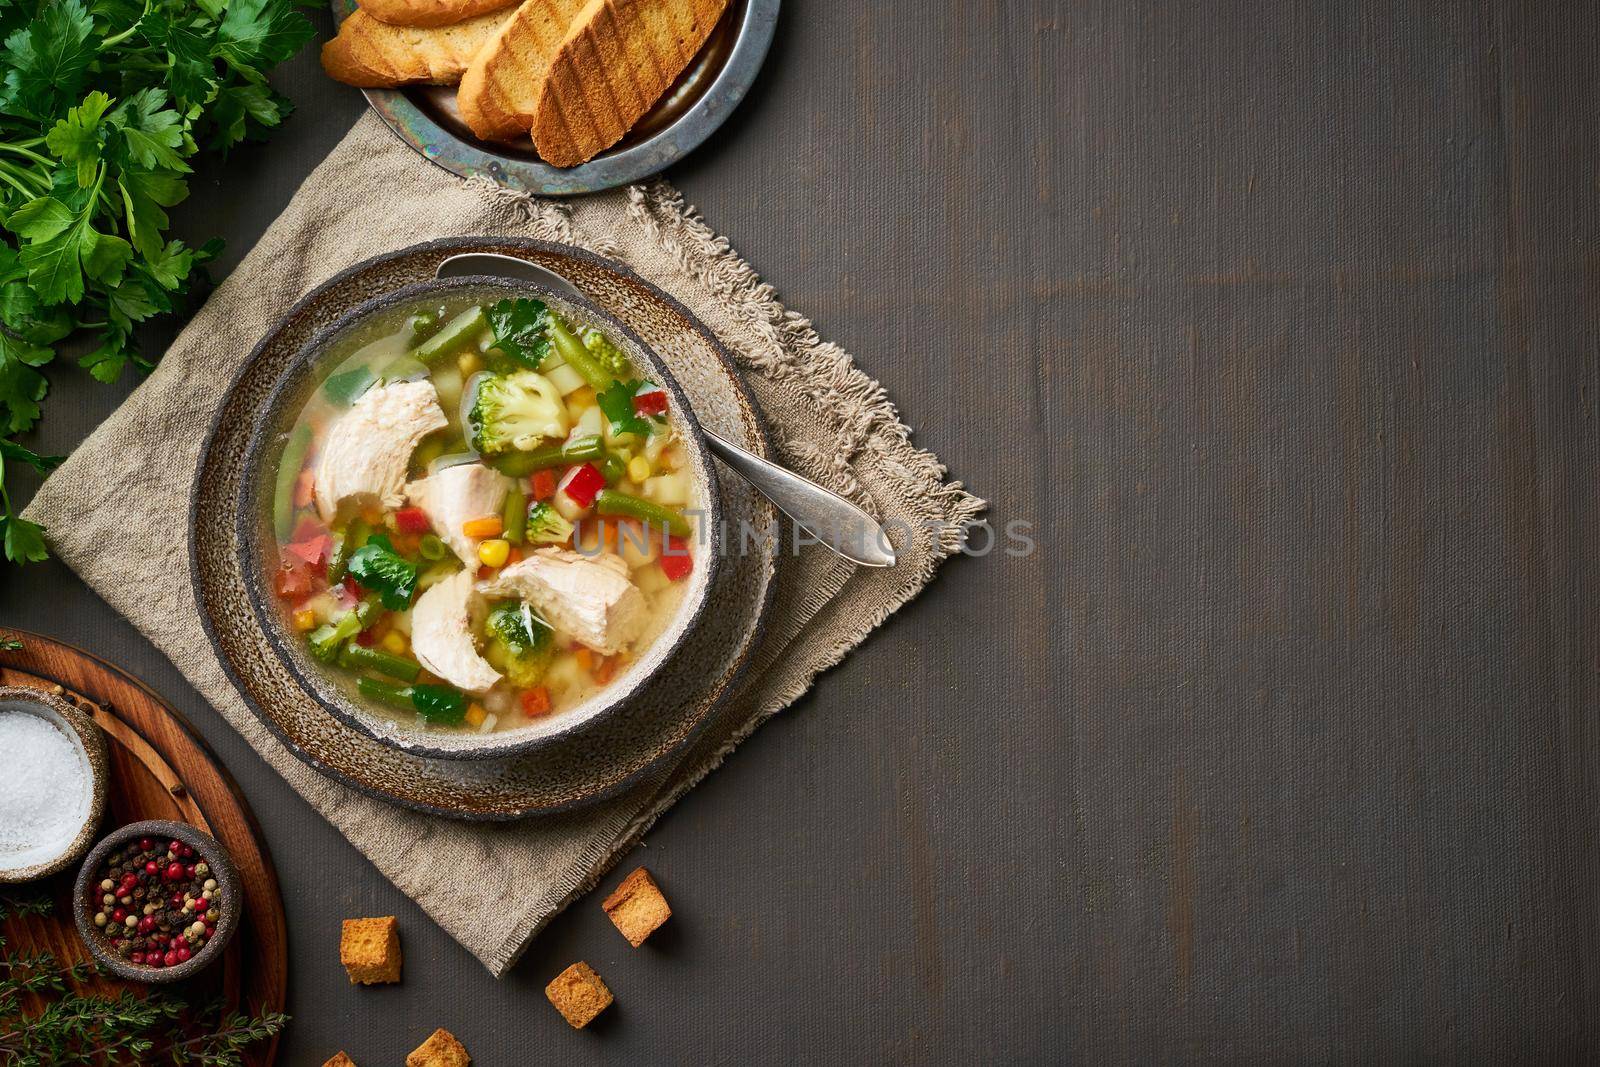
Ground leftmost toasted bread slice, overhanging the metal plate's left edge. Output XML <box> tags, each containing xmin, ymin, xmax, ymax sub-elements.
<box><xmin>322</xmin><ymin>10</ymin><xmax>512</xmax><ymax>88</ymax></box>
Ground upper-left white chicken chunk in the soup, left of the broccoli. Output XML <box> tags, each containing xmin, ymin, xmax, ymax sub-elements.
<box><xmin>312</xmin><ymin>381</ymin><xmax>448</xmax><ymax>522</ymax></box>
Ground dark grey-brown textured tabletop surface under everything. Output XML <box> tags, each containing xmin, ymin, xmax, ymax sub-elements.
<box><xmin>0</xmin><ymin>0</ymin><xmax>1600</xmax><ymax>1067</ymax></box>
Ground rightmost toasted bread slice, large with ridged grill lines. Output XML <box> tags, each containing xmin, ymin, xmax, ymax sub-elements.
<box><xmin>530</xmin><ymin>0</ymin><xmax>728</xmax><ymax>166</ymax></box>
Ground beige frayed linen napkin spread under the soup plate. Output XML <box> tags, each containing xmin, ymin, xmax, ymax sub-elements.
<box><xmin>27</xmin><ymin>114</ymin><xmax>982</xmax><ymax>974</ymax></box>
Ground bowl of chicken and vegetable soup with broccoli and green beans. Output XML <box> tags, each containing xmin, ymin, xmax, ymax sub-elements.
<box><xmin>238</xmin><ymin>278</ymin><xmax>722</xmax><ymax>758</ymax></box>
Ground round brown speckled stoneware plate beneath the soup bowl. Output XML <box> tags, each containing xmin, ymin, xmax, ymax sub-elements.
<box><xmin>190</xmin><ymin>238</ymin><xmax>778</xmax><ymax>819</ymax></box>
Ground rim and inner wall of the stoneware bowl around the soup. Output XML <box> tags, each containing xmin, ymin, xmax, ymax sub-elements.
<box><xmin>238</xmin><ymin>277</ymin><xmax>723</xmax><ymax>760</ymax></box>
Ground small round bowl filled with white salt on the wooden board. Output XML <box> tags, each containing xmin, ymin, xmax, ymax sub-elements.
<box><xmin>0</xmin><ymin>686</ymin><xmax>106</xmax><ymax>883</ymax></box>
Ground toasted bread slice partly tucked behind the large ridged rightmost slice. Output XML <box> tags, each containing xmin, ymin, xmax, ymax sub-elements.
<box><xmin>456</xmin><ymin>0</ymin><xmax>586</xmax><ymax>141</ymax></box>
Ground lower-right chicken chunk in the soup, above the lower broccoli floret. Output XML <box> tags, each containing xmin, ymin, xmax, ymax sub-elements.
<box><xmin>478</xmin><ymin>549</ymin><xmax>650</xmax><ymax>656</ymax></box>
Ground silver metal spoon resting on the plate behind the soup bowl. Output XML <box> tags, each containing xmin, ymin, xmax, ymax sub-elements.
<box><xmin>434</xmin><ymin>253</ymin><xmax>894</xmax><ymax>566</ymax></box>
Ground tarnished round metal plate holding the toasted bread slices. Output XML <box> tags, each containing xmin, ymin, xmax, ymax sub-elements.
<box><xmin>344</xmin><ymin>0</ymin><xmax>779</xmax><ymax>197</ymax></box>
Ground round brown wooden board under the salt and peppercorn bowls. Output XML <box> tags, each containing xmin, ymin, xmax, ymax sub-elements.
<box><xmin>0</xmin><ymin>630</ymin><xmax>288</xmax><ymax>1067</ymax></box>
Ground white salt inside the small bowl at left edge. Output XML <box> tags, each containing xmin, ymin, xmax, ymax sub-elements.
<box><xmin>0</xmin><ymin>707</ymin><xmax>93</xmax><ymax>869</ymax></box>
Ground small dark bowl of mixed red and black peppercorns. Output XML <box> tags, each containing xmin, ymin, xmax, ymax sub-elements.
<box><xmin>74</xmin><ymin>819</ymin><xmax>243</xmax><ymax>982</ymax></box>
